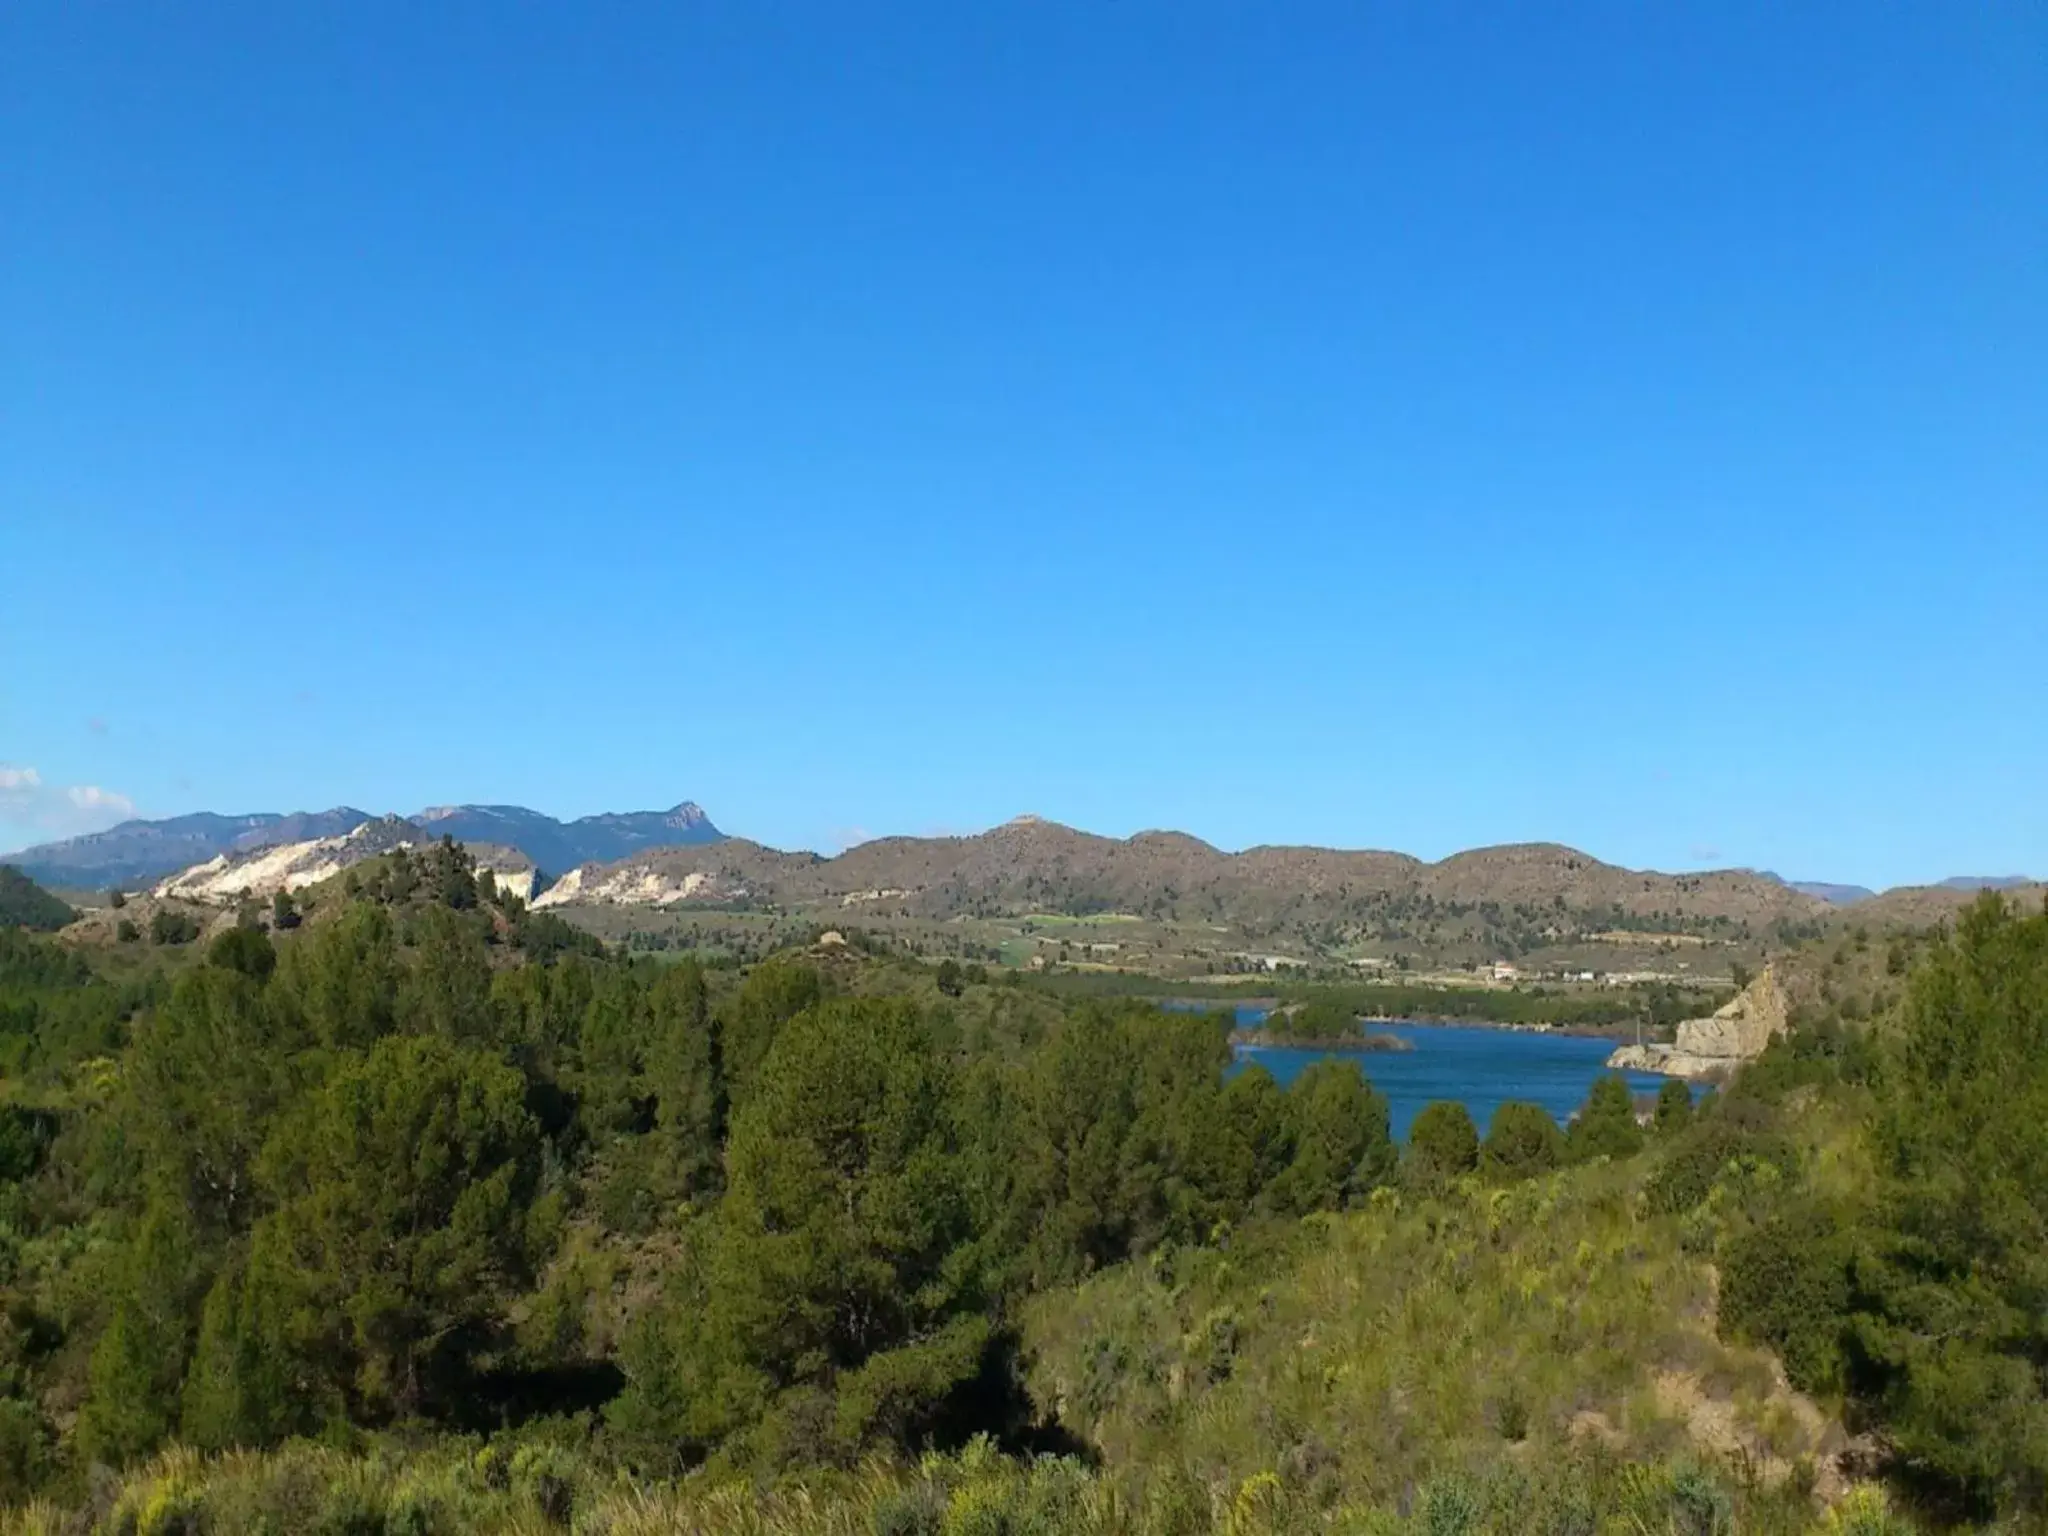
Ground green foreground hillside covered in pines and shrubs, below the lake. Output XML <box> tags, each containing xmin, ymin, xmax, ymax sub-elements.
<box><xmin>0</xmin><ymin>844</ymin><xmax>2048</xmax><ymax>1532</ymax></box>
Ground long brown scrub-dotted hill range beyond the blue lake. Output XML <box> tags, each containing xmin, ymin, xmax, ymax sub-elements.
<box><xmin>541</xmin><ymin>817</ymin><xmax>2039</xmax><ymax>979</ymax></box>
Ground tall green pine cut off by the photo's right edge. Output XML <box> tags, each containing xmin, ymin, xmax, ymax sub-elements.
<box><xmin>1851</xmin><ymin>895</ymin><xmax>2048</xmax><ymax>1516</ymax></box>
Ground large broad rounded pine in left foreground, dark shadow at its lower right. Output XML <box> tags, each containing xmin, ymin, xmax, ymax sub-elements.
<box><xmin>260</xmin><ymin>1034</ymin><xmax>541</xmax><ymax>1417</ymax></box>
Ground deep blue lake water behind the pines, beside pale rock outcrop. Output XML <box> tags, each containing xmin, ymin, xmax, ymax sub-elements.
<box><xmin>1204</xmin><ymin>1010</ymin><xmax>1665</xmax><ymax>1141</ymax></box>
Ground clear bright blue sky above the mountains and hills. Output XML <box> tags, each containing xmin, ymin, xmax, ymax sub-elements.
<box><xmin>0</xmin><ymin>0</ymin><xmax>2048</xmax><ymax>885</ymax></box>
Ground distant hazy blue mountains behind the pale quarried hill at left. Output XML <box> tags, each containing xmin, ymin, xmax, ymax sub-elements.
<box><xmin>4</xmin><ymin>801</ymin><xmax>725</xmax><ymax>891</ymax></box>
